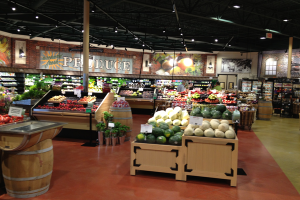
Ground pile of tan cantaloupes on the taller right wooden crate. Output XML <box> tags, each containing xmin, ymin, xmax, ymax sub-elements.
<box><xmin>184</xmin><ymin>119</ymin><xmax>236</xmax><ymax>139</ymax></box>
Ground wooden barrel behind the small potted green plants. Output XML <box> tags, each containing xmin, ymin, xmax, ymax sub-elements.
<box><xmin>109</xmin><ymin>107</ymin><xmax>132</xmax><ymax>140</ymax></box>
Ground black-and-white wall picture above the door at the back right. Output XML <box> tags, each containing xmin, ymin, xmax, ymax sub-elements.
<box><xmin>221</xmin><ymin>58</ymin><xmax>252</xmax><ymax>73</ymax></box>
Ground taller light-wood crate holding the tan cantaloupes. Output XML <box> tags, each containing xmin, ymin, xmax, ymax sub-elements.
<box><xmin>182</xmin><ymin>136</ymin><xmax>238</xmax><ymax>186</ymax></box>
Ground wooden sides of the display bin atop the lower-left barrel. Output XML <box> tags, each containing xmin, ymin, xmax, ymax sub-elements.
<box><xmin>0</xmin><ymin>126</ymin><xmax>63</xmax><ymax>151</ymax></box>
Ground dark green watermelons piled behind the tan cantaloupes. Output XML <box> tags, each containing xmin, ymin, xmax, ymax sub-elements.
<box><xmin>191</xmin><ymin>104</ymin><xmax>232</xmax><ymax>120</ymax></box>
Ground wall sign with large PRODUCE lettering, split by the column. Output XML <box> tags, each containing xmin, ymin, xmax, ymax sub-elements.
<box><xmin>40</xmin><ymin>51</ymin><xmax>132</xmax><ymax>74</ymax></box>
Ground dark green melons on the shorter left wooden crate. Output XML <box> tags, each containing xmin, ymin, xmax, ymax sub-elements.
<box><xmin>136</xmin><ymin>125</ymin><xmax>183</xmax><ymax>145</ymax></box>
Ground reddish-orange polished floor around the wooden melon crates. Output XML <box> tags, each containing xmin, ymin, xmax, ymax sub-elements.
<box><xmin>0</xmin><ymin>115</ymin><xmax>300</xmax><ymax>200</ymax></box>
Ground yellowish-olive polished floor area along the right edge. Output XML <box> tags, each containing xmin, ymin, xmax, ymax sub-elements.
<box><xmin>252</xmin><ymin>115</ymin><xmax>300</xmax><ymax>193</ymax></box>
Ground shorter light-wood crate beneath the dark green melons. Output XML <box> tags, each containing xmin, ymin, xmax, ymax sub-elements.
<box><xmin>130</xmin><ymin>141</ymin><xmax>184</xmax><ymax>180</ymax></box>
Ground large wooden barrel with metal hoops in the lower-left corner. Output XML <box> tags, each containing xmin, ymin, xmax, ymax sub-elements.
<box><xmin>2</xmin><ymin>139</ymin><xmax>53</xmax><ymax>198</ymax></box>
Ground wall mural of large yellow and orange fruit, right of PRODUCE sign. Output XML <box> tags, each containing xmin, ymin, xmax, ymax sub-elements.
<box><xmin>152</xmin><ymin>53</ymin><xmax>206</xmax><ymax>76</ymax></box>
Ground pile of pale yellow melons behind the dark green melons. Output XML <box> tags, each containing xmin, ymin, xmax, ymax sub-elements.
<box><xmin>148</xmin><ymin>107</ymin><xmax>190</xmax><ymax>126</ymax></box>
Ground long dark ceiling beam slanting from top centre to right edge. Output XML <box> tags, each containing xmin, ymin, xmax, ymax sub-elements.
<box><xmin>125</xmin><ymin>0</ymin><xmax>300</xmax><ymax>39</ymax></box>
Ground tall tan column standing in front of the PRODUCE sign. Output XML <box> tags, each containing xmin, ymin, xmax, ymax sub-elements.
<box><xmin>83</xmin><ymin>0</ymin><xmax>90</xmax><ymax>92</ymax></box>
